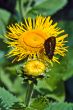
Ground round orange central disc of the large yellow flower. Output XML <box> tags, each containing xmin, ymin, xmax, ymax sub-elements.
<box><xmin>20</xmin><ymin>31</ymin><xmax>45</xmax><ymax>48</ymax></box>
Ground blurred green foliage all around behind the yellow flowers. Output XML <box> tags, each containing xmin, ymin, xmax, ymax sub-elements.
<box><xmin>0</xmin><ymin>0</ymin><xmax>73</xmax><ymax>110</ymax></box>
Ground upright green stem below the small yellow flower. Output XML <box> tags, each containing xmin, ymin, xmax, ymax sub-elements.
<box><xmin>25</xmin><ymin>82</ymin><xmax>34</xmax><ymax>107</ymax></box>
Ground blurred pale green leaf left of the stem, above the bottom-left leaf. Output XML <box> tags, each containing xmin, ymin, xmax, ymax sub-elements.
<box><xmin>0</xmin><ymin>66</ymin><xmax>25</xmax><ymax>94</ymax></box>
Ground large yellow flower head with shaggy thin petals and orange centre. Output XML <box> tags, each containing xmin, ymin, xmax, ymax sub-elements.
<box><xmin>6</xmin><ymin>16</ymin><xmax>67</xmax><ymax>62</ymax></box>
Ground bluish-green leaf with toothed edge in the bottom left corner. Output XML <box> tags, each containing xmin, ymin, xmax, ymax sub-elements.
<box><xmin>0</xmin><ymin>87</ymin><xmax>18</xmax><ymax>110</ymax></box>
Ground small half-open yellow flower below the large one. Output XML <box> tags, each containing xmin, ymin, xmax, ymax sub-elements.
<box><xmin>24</xmin><ymin>60</ymin><xmax>45</xmax><ymax>76</ymax></box>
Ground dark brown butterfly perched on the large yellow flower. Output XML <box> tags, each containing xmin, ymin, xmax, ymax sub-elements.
<box><xmin>44</xmin><ymin>36</ymin><xmax>56</xmax><ymax>60</ymax></box>
